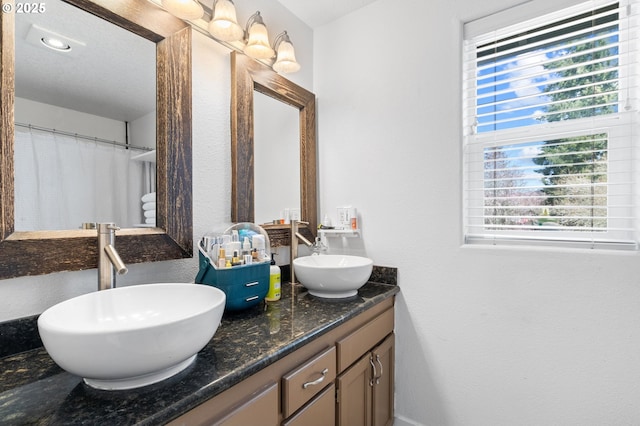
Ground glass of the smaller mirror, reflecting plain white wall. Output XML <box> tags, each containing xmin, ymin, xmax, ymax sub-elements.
<box><xmin>253</xmin><ymin>92</ymin><xmax>300</xmax><ymax>223</ymax></box>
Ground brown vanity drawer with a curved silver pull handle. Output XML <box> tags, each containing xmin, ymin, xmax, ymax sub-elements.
<box><xmin>282</xmin><ymin>346</ymin><xmax>336</xmax><ymax>418</ymax></box>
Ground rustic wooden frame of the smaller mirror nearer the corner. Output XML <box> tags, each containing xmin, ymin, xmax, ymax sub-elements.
<box><xmin>231</xmin><ymin>52</ymin><xmax>318</xmax><ymax>235</ymax></box>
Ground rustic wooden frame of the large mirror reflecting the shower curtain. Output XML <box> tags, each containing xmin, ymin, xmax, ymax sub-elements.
<box><xmin>0</xmin><ymin>0</ymin><xmax>193</xmax><ymax>279</ymax></box>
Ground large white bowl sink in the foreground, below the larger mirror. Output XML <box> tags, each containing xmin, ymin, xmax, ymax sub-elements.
<box><xmin>38</xmin><ymin>283</ymin><xmax>225</xmax><ymax>390</ymax></box>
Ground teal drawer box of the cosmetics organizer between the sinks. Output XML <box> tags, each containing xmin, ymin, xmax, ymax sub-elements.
<box><xmin>195</xmin><ymin>249</ymin><xmax>271</xmax><ymax>311</ymax></box>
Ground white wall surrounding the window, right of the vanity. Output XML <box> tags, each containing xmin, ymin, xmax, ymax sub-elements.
<box><xmin>314</xmin><ymin>0</ymin><xmax>640</xmax><ymax>426</ymax></box>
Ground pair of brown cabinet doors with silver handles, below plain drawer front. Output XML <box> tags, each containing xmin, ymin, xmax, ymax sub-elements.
<box><xmin>336</xmin><ymin>334</ymin><xmax>394</xmax><ymax>426</ymax></box>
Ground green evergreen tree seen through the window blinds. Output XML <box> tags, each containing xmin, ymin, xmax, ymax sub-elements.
<box><xmin>533</xmin><ymin>32</ymin><xmax>618</xmax><ymax>228</ymax></box>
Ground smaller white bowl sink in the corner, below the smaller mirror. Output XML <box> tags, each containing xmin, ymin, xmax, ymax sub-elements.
<box><xmin>293</xmin><ymin>254</ymin><xmax>373</xmax><ymax>299</ymax></box>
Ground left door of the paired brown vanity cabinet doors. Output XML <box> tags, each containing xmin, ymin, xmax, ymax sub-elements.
<box><xmin>337</xmin><ymin>353</ymin><xmax>372</xmax><ymax>426</ymax></box>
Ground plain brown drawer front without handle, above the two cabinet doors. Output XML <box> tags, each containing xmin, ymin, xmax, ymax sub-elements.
<box><xmin>336</xmin><ymin>308</ymin><xmax>394</xmax><ymax>373</ymax></box>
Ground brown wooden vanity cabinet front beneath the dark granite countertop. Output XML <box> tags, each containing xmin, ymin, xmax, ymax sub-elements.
<box><xmin>169</xmin><ymin>298</ymin><xmax>394</xmax><ymax>426</ymax></box>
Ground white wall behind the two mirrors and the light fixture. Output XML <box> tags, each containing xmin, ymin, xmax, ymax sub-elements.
<box><xmin>0</xmin><ymin>0</ymin><xmax>313</xmax><ymax>322</ymax></box>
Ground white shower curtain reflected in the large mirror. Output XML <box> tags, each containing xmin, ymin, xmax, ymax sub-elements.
<box><xmin>14</xmin><ymin>126</ymin><xmax>144</xmax><ymax>231</ymax></box>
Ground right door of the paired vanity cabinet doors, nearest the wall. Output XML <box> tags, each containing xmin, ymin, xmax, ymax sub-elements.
<box><xmin>371</xmin><ymin>334</ymin><xmax>395</xmax><ymax>426</ymax></box>
